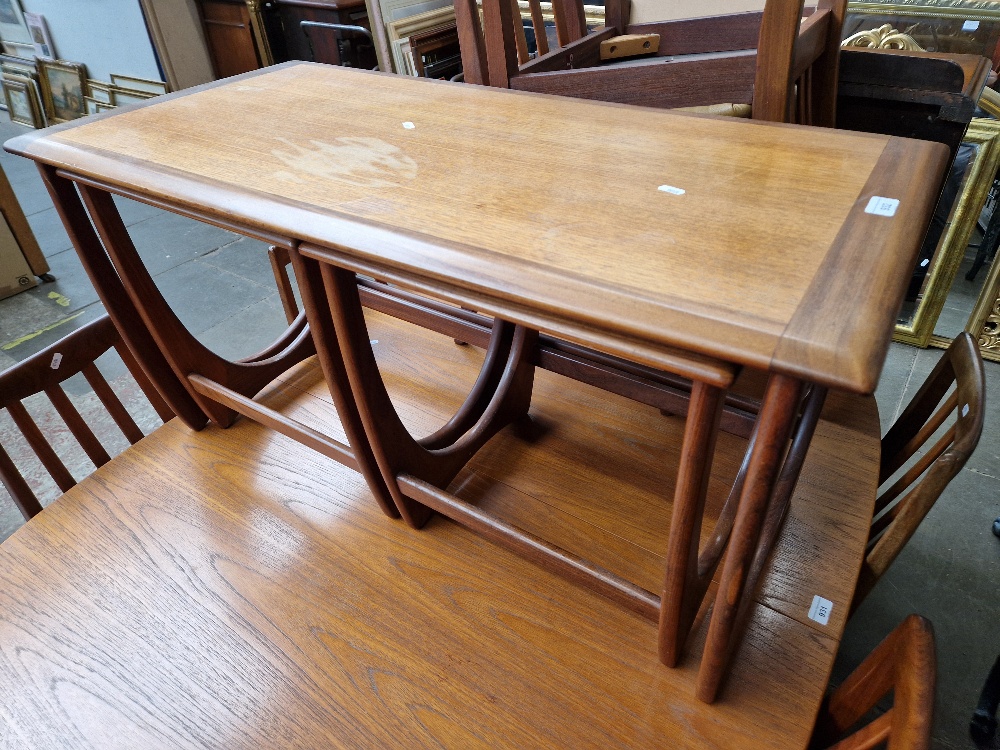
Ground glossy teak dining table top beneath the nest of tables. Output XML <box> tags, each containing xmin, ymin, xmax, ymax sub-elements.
<box><xmin>0</xmin><ymin>312</ymin><xmax>879</xmax><ymax>750</ymax></box>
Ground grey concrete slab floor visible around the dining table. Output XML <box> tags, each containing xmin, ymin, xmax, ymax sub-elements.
<box><xmin>0</xmin><ymin>114</ymin><xmax>1000</xmax><ymax>748</ymax></box>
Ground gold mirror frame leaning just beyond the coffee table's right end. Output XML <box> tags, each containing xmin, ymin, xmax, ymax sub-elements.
<box><xmin>893</xmin><ymin>118</ymin><xmax>1000</xmax><ymax>347</ymax></box>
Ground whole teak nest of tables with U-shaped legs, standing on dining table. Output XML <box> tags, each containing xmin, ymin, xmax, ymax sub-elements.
<box><xmin>8</xmin><ymin>64</ymin><xmax>945</xmax><ymax>700</ymax></box>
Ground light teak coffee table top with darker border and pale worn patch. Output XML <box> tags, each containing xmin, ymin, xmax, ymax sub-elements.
<box><xmin>6</xmin><ymin>63</ymin><xmax>947</xmax><ymax>393</ymax></box>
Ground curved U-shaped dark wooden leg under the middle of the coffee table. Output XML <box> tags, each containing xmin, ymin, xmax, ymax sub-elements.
<box><xmin>324</xmin><ymin>263</ymin><xmax>538</xmax><ymax>528</ymax></box>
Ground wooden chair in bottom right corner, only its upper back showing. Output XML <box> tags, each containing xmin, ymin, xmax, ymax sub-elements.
<box><xmin>811</xmin><ymin>615</ymin><xmax>937</xmax><ymax>750</ymax></box>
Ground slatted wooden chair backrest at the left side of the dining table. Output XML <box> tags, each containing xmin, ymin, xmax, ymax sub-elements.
<box><xmin>0</xmin><ymin>316</ymin><xmax>173</xmax><ymax>518</ymax></box>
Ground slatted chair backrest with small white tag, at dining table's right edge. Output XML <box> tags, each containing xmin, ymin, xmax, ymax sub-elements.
<box><xmin>851</xmin><ymin>333</ymin><xmax>986</xmax><ymax>612</ymax></box>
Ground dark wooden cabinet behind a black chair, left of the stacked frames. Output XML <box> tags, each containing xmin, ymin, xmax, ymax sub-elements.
<box><xmin>272</xmin><ymin>0</ymin><xmax>377</xmax><ymax>70</ymax></box>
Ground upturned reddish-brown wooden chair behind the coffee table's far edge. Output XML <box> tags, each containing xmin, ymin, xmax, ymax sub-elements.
<box><xmin>455</xmin><ymin>0</ymin><xmax>847</xmax><ymax>127</ymax></box>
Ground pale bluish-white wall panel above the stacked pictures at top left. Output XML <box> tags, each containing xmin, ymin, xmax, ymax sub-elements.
<box><xmin>21</xmin><ymin>0</ymin><xmax>161</xmax><ymax>81</ymax></box>
